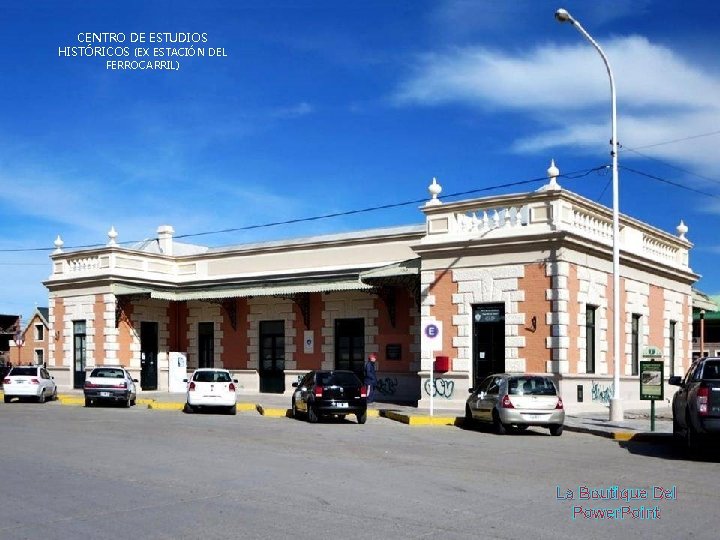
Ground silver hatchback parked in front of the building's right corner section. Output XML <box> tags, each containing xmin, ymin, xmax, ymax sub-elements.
<box><xmin>465</xmin><ymin>373</ymin><xmax>565</xmax><ymax>436</ymax></box>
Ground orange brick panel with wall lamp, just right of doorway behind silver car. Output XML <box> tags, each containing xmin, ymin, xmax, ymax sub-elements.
<box><xmin>518</xmin><ymin>263</ymin><xmax>552</xmax><ymax>373</ymax></box>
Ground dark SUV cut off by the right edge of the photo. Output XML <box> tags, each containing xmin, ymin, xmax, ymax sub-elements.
<box><xmin>668</xmin><ymin>357</ymin><xmax>720</xmax><ymax>451</ymax></box>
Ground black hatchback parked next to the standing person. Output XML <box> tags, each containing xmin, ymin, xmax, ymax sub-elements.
<box><xmin>292</xmin><ymin>370</ymin><xmax>367</xmax><ymax>424</ymax></box>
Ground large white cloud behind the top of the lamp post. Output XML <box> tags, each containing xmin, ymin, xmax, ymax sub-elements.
<box><xmin>393</xmin><ymin>36</ymin><xmax>720</xmax><ymax>173</ymax></box>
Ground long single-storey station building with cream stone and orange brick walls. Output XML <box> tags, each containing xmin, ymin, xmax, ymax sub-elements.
<box><xmin>45</xmin><ymin>161</ymin><xmax>698</xmax><ymax>407</ymax></box>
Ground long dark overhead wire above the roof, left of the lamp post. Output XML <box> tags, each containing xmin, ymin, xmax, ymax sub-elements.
<box><xmin>0</xmin><ymin>165</ymin><xmax>607</xmax><ymax>253</ymax></box>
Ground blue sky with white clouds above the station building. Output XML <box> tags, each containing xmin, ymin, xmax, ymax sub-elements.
<box><xmin>0</xmin><ymin>0</ymin><xmax>720</xmax><ymax>324</ymax></box>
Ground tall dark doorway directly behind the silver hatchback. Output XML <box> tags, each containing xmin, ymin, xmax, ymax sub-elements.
<box><xmin>472</xmin><ymin>304</ymin><xmax>505</xmax><ymax>388</ymax></box>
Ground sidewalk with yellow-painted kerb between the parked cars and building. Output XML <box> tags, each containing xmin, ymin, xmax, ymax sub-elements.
<box><xmin>0</xmin><ymin>390</ymin><xmax>672</xmax><ymax>442</ymax></box>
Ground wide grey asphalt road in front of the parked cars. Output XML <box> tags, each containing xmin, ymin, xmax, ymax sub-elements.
<box><xmin>0</xmin><ymin>403</ymin><xmax>720</xmax><ymax>540</ymax></box>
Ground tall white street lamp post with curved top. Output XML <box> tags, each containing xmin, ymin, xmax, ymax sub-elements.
<box><xmin>555</xmin><ymin>9</ymin><xmax>624</xmax><ymax>421</ymax></box>
